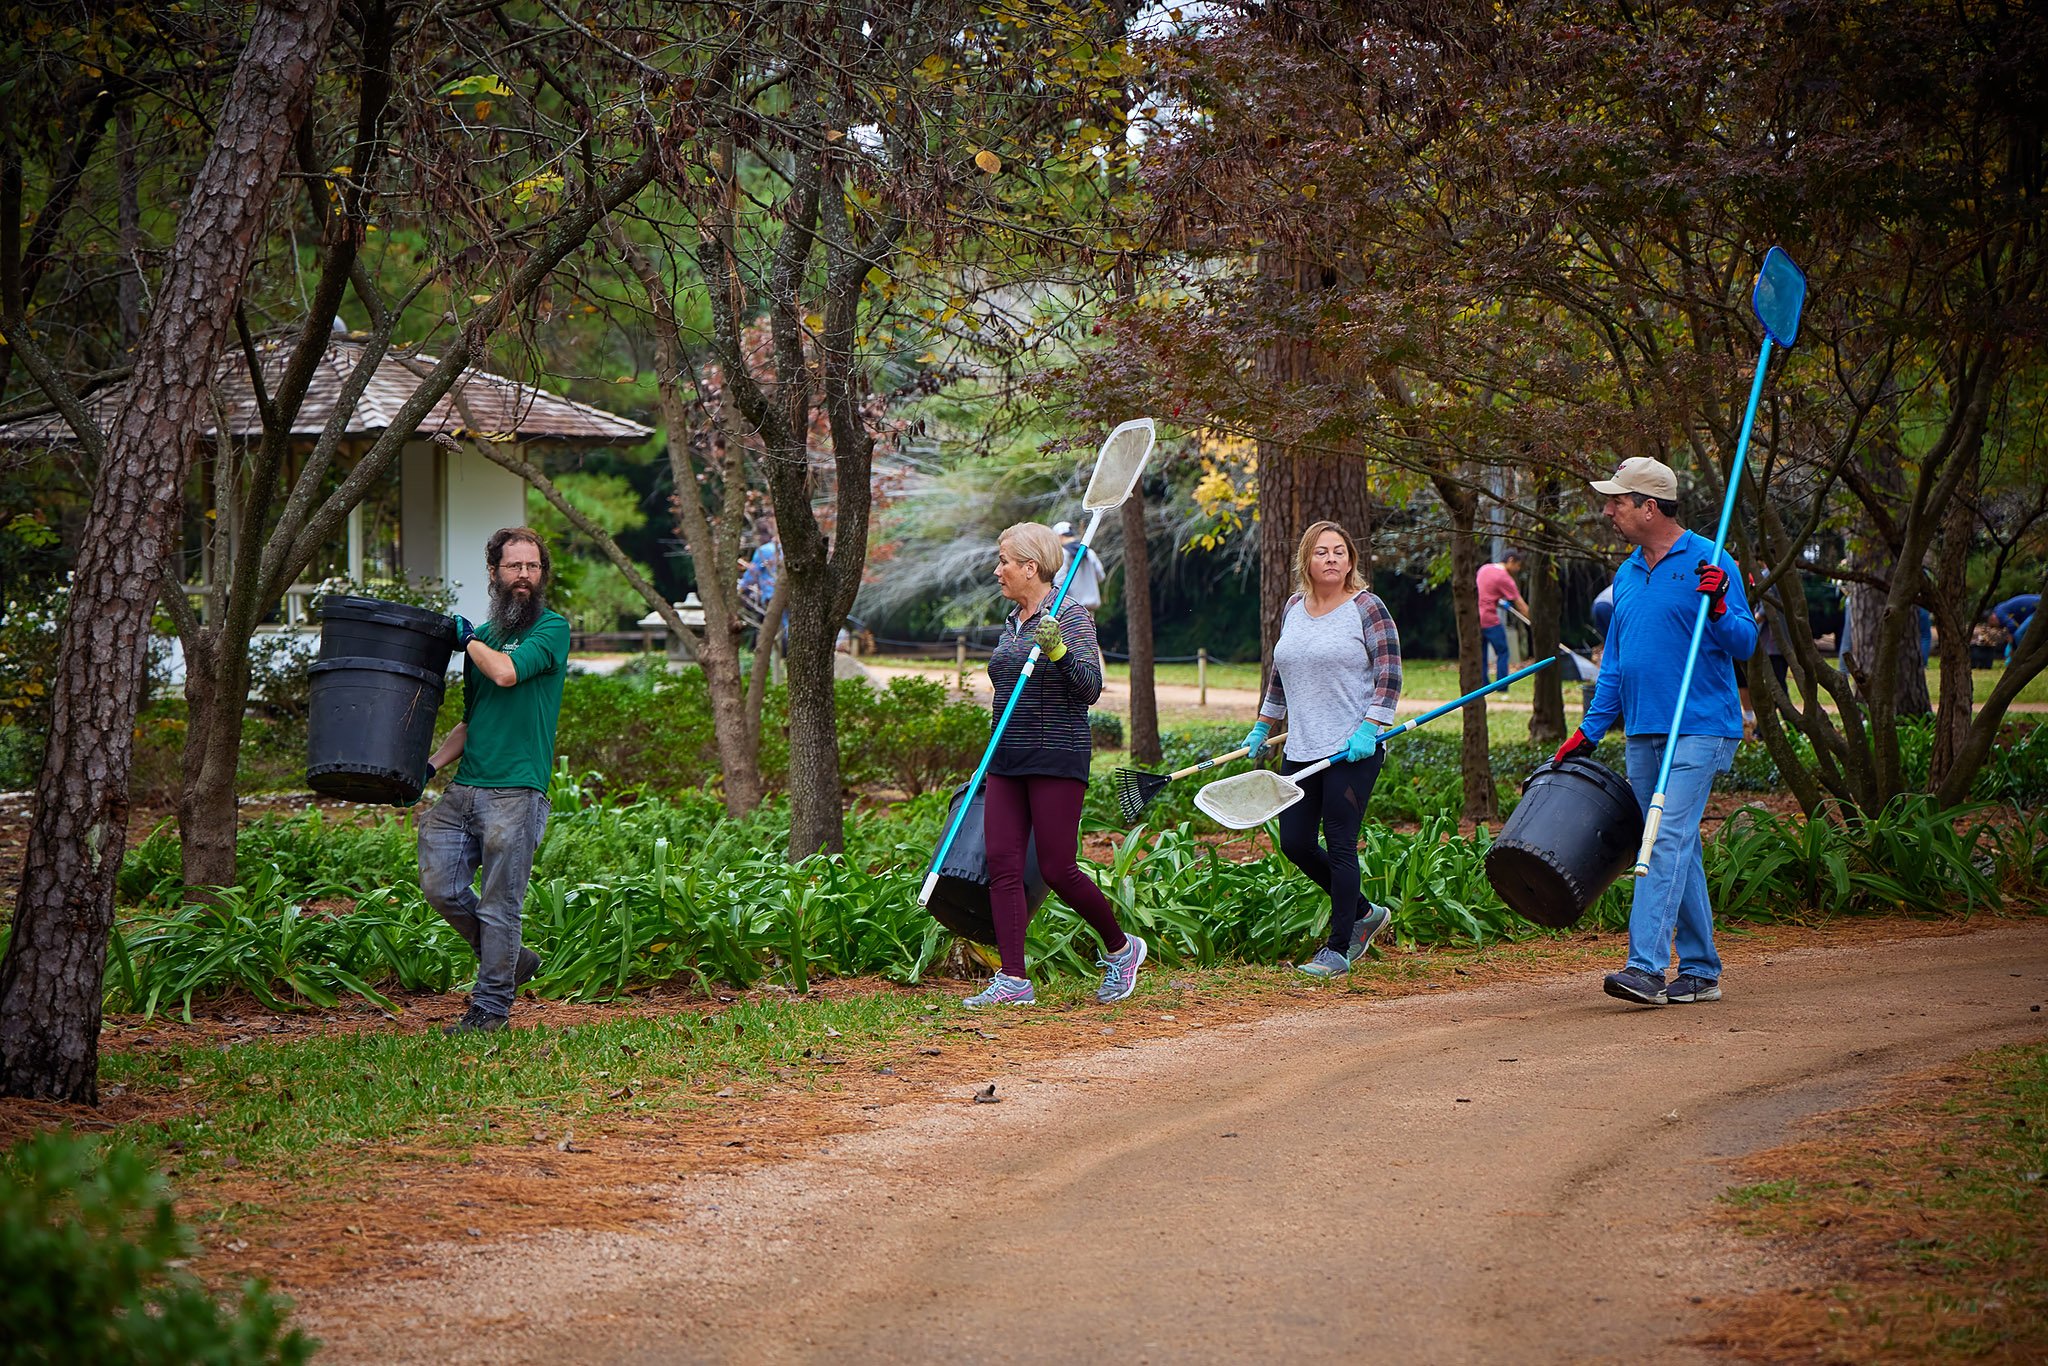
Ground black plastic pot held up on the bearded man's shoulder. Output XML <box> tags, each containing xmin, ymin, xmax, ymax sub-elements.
<box><xmin>305</xmin><ymin>596</ymin><xmax>455</xmax><ymax>807</ymax></box>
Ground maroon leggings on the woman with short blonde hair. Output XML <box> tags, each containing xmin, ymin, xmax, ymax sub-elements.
<box><xmin>981</xmin><ymin>774</ymin><xmax>1124</xmax><ymax>977</ymax></box>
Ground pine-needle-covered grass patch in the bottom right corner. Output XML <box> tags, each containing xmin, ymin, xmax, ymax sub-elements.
<box><xmin>1710</xmin><ymin>1044</ymin><xmax>2048</xmax><ymax>1362</ymax></box>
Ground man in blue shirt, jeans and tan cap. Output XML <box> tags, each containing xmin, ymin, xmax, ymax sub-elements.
<box><xmin>1556</xmin><ymin>457</ymin><xmax>1757</xmax><ymax>1006</ymax></box>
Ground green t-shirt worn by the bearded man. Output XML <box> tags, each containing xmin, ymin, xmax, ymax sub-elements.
<box><xmin>455</xmin><ymin>612</ymin><xmax>569</xmax><ymax>793</ymax></box>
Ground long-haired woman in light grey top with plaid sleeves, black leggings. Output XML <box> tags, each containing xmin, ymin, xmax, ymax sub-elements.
<box><xmin>1245</xmin><ymin>522</ymin><xmax>1401</xmax><ymax>977</ymax></box>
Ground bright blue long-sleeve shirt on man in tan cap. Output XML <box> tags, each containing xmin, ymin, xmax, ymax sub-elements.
<box><xmin>1579</xmin><ymin>530</ymin><xmax>1757</xmax><ymax>743</ymax></box>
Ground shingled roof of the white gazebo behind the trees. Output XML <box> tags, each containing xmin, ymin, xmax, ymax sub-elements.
<box><xmin>0</xmin><ymin>338</ymin><xmax>653</xmax><ymax>446</ymax></box>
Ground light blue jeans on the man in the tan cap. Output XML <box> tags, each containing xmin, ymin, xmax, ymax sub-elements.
<box><xmin>1628</xmin><ymin>735</ymin><xmax>1737</xmax><ymax>981</ymax></box>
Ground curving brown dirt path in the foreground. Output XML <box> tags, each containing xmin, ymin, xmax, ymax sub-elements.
<box><xmin>303</xmin><ymin>922</ymin><xmax>2048</xmax><ymax>1362</ymax></box>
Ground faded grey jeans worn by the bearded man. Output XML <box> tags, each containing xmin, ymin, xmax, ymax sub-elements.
<box><xmin>420</xmin><ymin>782</ymin><xmax>549</xmax><ymax>1016</ymax></box>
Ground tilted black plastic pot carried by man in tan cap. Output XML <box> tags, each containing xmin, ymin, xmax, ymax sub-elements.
<box><xmin>1487</xmin><ymin>754</ymin><xmax>1642</xmax><ymax>930</ymax></box>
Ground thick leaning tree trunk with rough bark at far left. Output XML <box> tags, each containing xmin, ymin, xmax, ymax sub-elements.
<box><xmin>0</xmin><ymin>0</ymin><xmax>338</xmax><ymax>1104</ymax></box>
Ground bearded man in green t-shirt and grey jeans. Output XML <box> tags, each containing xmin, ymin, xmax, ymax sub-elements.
<box><xmin>420</xmin><ymin>526</ymin><xmax>569</xmax><ymax>1034</ymax></box>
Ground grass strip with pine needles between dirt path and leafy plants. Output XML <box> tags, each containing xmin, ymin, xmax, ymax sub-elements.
<box><xmin>24</xmin><ymin>936</ymin><xmax>1602</xmax><ymax>1186</ymax></box>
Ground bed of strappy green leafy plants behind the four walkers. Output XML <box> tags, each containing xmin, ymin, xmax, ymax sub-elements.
<box><xmin>68</xmin><ymin>733</ymin><xmax>2048</xmax><ymax>1014</ymax></box>
